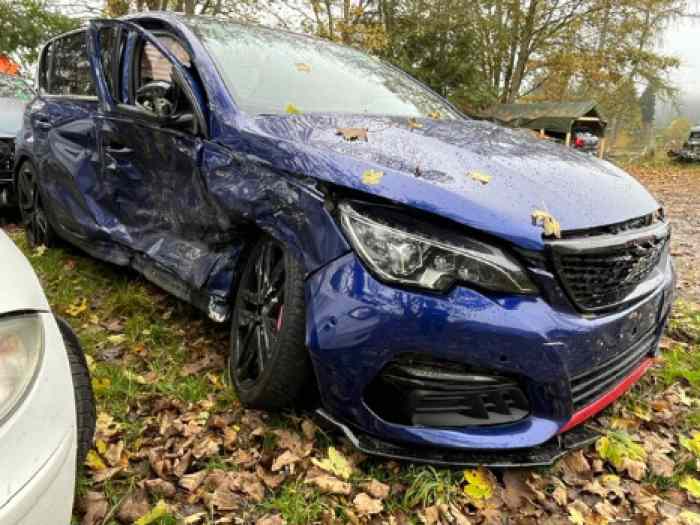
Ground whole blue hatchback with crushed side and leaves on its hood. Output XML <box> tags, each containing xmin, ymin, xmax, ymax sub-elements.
<box><xmin>16</xmin><ymin>12</ymin><xmax>674</xmax><ymax>465</ymax></box>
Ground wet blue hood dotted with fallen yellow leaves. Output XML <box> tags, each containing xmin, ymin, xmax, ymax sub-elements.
<box><xmin>238</xmin><ymin>114</ymin><xmax>658</xmax><ymax>249</ymax></box>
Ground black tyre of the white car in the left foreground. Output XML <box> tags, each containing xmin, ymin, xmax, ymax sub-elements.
<box><xmin>56</xmin><ymin>317</ymin><xmax>97</xmax><ymax>468</ymax></box>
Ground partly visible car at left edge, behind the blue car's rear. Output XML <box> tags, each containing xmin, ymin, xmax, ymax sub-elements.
<box><xmin>0</xmin><ymin>73</ymin><xmax>34</xmax><ymax>206</ymax></box>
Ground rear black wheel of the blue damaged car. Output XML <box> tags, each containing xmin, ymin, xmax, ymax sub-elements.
<box><xmin>17</xmin><ymin>161</ymin><xmax>57</xmax><ymax>248</ymax></box>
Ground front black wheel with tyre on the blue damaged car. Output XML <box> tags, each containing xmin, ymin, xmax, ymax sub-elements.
<box><xmin>229</xmin><ymin>236</ymin><xmax>314</xmax><ymax>410</ymax></box>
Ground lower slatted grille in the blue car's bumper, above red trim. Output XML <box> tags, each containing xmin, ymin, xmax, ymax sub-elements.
<box><xmin>571</xmin><ymin>330</ymin><xmax>656</xmax><ymax>411</ymax></box>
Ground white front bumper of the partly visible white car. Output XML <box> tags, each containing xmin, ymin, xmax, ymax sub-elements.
<box><xmin>0</xmin><ymin>313</ymin><xmax>77</xmax><ymax>525</ymax></box>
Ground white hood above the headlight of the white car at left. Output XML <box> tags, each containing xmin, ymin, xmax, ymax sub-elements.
<box><xmin>0</xmin><ymin>230</ymin><xmax>49</xmax><ymax>315</ymax></box>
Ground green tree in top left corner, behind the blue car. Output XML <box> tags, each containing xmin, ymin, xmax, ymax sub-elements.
<box><xmin>0</xmin><ymin>0</ymin><xmax>80</xmax><ymax>68</ymax></box>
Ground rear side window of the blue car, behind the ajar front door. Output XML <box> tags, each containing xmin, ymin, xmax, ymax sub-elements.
<box><xmin>48</xmin><ymin>31</ymin><xmax>97</xmax><ymax>96</ymax></box>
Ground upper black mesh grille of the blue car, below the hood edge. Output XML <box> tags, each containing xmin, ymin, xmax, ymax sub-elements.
<box><xmin>551</xmin><ymin>222</ymin><xmax>669</xmax><ymax>312</ymax></box>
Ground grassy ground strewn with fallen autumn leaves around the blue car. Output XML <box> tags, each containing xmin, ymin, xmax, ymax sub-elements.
<box><xmin>1</xmin><ymin>162</ymin><xmax>700</xmax><ymax>525</ymax></box>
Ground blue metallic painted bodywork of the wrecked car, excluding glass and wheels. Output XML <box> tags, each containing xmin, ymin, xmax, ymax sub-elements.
<box><xmin>13</xmin><ymin>13</ymin><xmax>672</xmax><ymax>454</ymax></box>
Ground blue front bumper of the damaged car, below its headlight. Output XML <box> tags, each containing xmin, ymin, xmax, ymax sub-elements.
<box><xmin>307</xmin><ymin>253</ymin><xmax>674</xmax><ymax>464</ymax></box>
